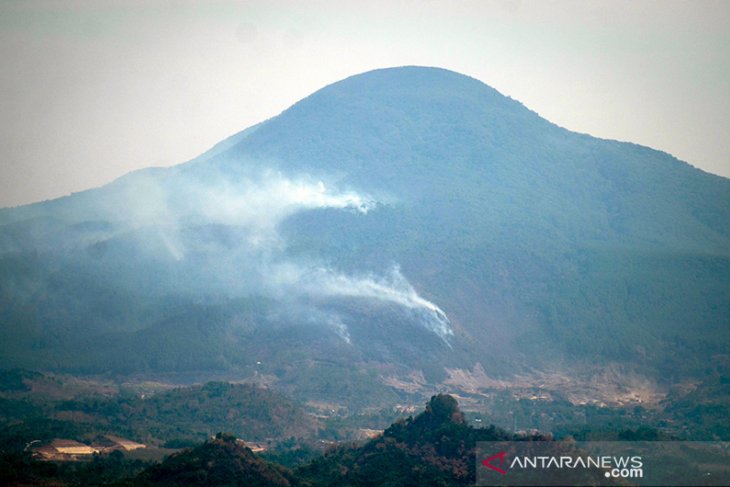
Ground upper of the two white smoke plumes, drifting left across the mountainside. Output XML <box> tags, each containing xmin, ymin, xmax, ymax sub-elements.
<box><xmin>121</xmin><ymin>170</ymin><xmax>376</xmax><ymax>255</ymax></box>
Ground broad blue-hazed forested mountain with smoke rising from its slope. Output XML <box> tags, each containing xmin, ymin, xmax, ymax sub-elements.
<box><xmin>0</xmin><ymin>67</ymin><xmax>730</xmax><ymax>406</ymax></box>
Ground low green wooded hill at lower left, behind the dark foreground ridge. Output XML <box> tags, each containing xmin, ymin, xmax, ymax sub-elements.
<box><xmin>0</xmin><ymin>374</ymin><xmax>320</xmax><ymax>452</ymax></box>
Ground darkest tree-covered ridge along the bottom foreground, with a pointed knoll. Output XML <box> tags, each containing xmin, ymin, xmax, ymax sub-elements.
<box><xmin>0</xmin><ymin>390</ymin><xmax>724</xmax><ymax>487</ymax></box>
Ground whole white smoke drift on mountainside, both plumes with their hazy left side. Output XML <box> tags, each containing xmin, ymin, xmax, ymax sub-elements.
<box><xmin>8</xmin><ymin>166</ymin><xmax>453</xmax><ymax>344</ymax></box>
